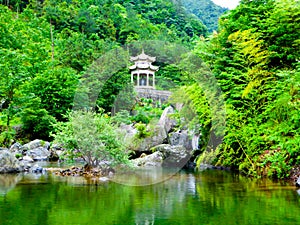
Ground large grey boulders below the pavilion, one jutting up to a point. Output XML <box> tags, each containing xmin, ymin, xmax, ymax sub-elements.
<box><xmin>123</xmin><ymin>106</ymin><xmax>199</xmax><ymax>168</ymax></box>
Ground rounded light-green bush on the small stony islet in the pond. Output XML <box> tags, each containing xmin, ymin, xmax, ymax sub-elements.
<box><xmin>54</xmin><ymin>111</ymin><xmax>128</xmax><ymax>167</ymax></box>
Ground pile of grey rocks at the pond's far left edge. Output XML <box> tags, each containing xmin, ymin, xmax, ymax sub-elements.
<box><xmin>0</xmin><ymin>140</ymin><xmax>60</xmax><ymax>173</ymax></box>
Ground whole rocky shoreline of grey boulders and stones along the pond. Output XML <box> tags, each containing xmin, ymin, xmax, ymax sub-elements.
<box><xmin>0</xmin><ymin>106</ymin><xmax>300</xmax><ymax>187</ymax></box>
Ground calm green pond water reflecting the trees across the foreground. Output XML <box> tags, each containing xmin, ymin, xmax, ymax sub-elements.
<box><xmin>0</xmin><ymin>170</ymin><xmax>300</xmax><ymax>225</ymax></box>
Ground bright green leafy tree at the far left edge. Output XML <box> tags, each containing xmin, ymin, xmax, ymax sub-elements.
<box><xmin>0</xmin><ymin>6</ymin><xmax>49</xmax><ymax>139</ymax></box>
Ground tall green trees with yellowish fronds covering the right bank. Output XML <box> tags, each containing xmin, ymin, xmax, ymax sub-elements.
<box><xmin>196</xmin><ymin>0</ymin><xmax>300</xmax><ymax>178</ymax></box>
